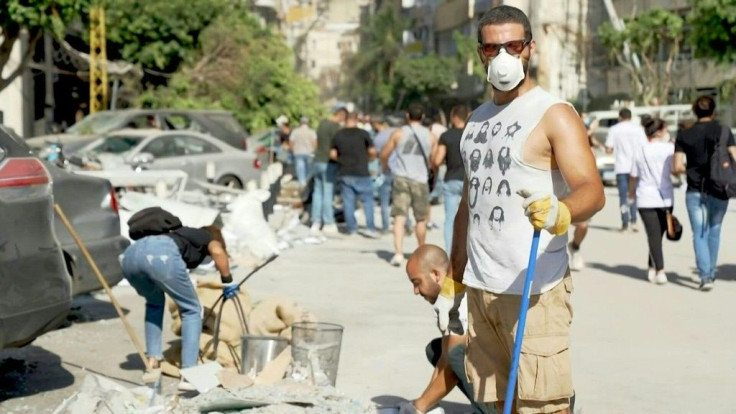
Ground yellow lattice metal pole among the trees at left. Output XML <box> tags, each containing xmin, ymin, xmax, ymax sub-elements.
<box><xmin>89</xmin><ymin>1</ymin><xmax>108</xmax><ymax>113</ymax></box>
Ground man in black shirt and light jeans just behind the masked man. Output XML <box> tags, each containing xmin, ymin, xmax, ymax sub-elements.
<box><xmin>432</xmin><ymin>105</ymin><xmax>472</xmax><ymax>252</ymax></box>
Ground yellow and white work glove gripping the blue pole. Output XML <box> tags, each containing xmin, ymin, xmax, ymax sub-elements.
<box><xmin>517</xmin><ymin>190</ymin><xmax>571</xmax><ymax>236</ymax></box>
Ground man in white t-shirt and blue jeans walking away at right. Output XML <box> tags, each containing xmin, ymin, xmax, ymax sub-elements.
<box><xmin>606</xmin><ymin>108</ymin><xmax>646</xmax><ymax>232</ymax></box>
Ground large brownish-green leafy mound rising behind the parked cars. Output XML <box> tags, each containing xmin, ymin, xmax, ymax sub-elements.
<box><xmin>141</xmin><ymin>12</ymin><xmax>324</xmax><ymax>131</ymax></box>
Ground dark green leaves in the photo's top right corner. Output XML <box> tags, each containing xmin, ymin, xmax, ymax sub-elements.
<box><xmin>688</xmin><ymin>0</ymin><xmax>736</xmax><ymax>63</ymax></box>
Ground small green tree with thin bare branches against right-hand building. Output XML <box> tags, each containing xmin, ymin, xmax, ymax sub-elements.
<box><xmin>598</xmin><ymin>8</ymin><xmax>684</xmax><ymax>104</ymax></box>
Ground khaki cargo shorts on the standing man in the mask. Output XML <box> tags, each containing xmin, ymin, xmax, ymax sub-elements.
<box><xmin>465</xmin><ymin>271</ymin><xmax>573</xmax><ymax>414</ymax></box>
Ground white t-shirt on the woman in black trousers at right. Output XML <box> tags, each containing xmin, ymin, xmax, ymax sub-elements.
<box><xmin>631</xmin><ymin>141</ymin><xmax>675</xmax><ymax>208</ymax></box>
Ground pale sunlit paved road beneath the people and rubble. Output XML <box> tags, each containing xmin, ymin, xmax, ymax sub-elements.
<box><xmin>0</xmin><ymin>189</ymin><xmax>736</xmax><ymax>414</ymax></box>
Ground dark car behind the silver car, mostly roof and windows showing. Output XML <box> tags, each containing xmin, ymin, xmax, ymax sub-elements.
<box><xmin>27</xmin><ymin>109</ymin><xmax>248</xmax><ymax>157</ymax></box>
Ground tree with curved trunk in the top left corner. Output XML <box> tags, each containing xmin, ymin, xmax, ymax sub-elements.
<box><xmin>0</xmin><ymin>0</ymin><xmax>89</xmax><ymax>91</ymax></box>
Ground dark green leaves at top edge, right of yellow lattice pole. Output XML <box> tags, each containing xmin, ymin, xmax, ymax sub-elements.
<box><xmin>105</xmin><ymin>0</ymin><xmax>229</xmax><ymax>72</ymax></box>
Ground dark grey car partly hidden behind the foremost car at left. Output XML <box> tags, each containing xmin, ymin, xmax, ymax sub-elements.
<box><xmin>46</xmin><ymin>163</ymin><xmax>130</xmax><ymax>295</ymax></box>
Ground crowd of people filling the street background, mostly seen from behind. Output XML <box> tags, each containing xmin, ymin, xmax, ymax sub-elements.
<box><xmin>277</xmin><ymin>96</ymin><xmax>736</xmax><ymax>291</ymax></box>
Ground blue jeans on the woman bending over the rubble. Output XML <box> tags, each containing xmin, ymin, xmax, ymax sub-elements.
<box><xmin>122</xmin><ymin>236</ymin><xmax>202</xmax><ymax>368</ymax></box>
